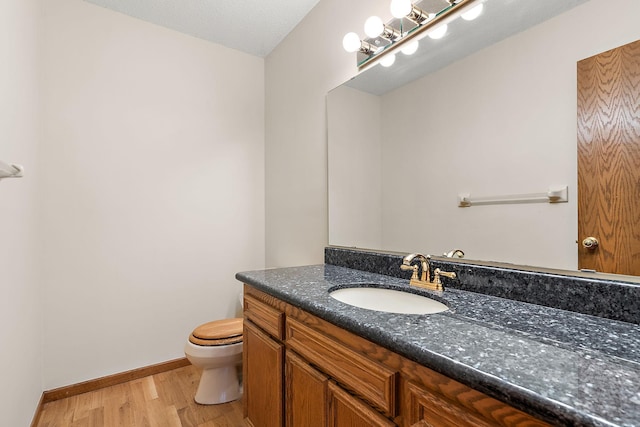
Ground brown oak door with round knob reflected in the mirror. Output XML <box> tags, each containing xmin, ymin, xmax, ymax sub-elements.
<box><xmin>578</xmin><ymin>40</ymin><xmax>640</xmax><ymax>275</ymax></box>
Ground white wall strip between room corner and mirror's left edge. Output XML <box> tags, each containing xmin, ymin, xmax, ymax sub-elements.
<box><xmin>265</xmin><ymin>0</ymin><xmax>389</xmax><ymax>267</ymax></box>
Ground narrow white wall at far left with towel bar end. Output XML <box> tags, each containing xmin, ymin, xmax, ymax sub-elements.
<box><xmin>0</xmin><ymin>0</ymin><xmax>42</xmax><ymax>426</ymax></box>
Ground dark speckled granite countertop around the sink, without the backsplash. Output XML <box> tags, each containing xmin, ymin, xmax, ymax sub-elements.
<box><xmin>236</xmin><ymin>264</ymin><xmax>640</xmax><ymax>426</ymax></box>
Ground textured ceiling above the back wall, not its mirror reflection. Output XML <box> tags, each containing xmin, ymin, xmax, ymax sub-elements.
<box><xmin>85</xmin><ymin>0</ymin><xmax>319</xmax><ymax>57</ymax></box>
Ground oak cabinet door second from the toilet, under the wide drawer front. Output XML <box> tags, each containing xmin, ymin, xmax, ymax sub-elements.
<box><xmin>285</xmin><ymin>351</ymin><xmax>329</xmax><ymax>427</ymax></box>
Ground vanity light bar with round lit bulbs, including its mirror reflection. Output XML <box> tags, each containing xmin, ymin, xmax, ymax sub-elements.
<box><xmin>342</xmin><ymin>0</ymin><xmax>490</xmax><ymax>70</ymax></box>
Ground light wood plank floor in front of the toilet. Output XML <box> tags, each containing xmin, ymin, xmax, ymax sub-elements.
<box><xmin>37</xmin><ymin>365</ymin><xmax>245</xmax><ymax>427</ymax></box>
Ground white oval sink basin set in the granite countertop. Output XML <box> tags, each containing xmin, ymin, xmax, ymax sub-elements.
<box><xmin>329</xmin><ymin>287</ymin><xmax>449</xmax><ymax>314</ymax></box>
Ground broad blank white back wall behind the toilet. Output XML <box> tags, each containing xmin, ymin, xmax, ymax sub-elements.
<box><xmin>40</xmin><ymin>0</ymin><xmax>264</xmax><ymax>389</ymax></box>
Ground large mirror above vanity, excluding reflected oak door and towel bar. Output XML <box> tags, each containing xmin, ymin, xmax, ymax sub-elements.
<box><xmin>327</xmin><ymin>0</ymin><xmax>640</xmax><ymax>278</ymax></box>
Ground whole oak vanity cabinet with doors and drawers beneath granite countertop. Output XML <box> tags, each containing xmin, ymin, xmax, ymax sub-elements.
<box><xmin>244</xmin><ymin>285</ymin><xmax>548</xmax><ymax>427</ymax></box>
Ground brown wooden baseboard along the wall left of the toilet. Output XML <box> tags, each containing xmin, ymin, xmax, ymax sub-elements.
<box><xmin>40</xmin><ymin>357</ymin><xmax>190</xmax><ymax>404</ymax></box>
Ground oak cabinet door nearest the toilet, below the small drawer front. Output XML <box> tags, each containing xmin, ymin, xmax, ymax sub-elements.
<box><xmin>242</xmin><ymin>321</ymin><xmax>284</xmax><ymax>427</ymax></box>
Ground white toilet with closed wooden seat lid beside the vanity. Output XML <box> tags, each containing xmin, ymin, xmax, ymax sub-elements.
<box><xmin>184</xmin><ymin>318</ymin><xmax>242</xmax><ymax>405</ymax></box>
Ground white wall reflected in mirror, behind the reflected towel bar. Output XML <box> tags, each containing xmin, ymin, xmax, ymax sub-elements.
<box><xmin>382</xmin><ymin>0</ymin><xmax>640</xmax><ymax>269</ymax></box>
